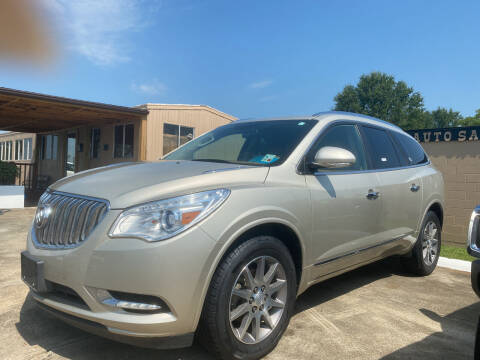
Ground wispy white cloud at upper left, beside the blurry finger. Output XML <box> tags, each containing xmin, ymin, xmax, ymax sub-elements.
<box><xmin>42</xmin><ymin>0</ymin><xmax>160</xmax><ymax>65</ymax></box>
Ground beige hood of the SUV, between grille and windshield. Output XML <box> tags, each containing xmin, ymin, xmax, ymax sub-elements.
<box><xmin>50</xmin><ymin>161</ymin><xmax>268</xmax><ymax>209</ymax></box>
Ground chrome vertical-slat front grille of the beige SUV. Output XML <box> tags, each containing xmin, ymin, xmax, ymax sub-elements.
<box><xmin>33</xmin><ymin>192</ymin><xmax>109</xmax><ymax>249</ymax></box>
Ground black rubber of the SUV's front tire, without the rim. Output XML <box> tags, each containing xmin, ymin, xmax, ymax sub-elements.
<box><xmin>212</xmin><ymin>236</ymin><xmax>297</xmax><ymax>359</ymax></box>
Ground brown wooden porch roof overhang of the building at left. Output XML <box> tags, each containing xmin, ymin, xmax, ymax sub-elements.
<box><xmin>0</xmin><ymin>87</ymin><xmax>148</xmax><ymax>133</ymax></box>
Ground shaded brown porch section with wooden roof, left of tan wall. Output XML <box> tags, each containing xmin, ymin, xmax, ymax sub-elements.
<box><xmin>0</xmin><ymin>87</ymin><xmax>148</xmax><ymax>201</ymax></box>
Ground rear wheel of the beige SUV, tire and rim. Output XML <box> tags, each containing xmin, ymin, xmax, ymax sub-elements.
<box><xmin>402</xmin><ymin>211</ymin><xmax>442</xmax><ymax>276</ymax></box>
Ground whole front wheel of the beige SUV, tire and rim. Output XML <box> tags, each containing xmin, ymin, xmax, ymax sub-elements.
<box><xmin>197</xmin><ymin>236</ymin><xmax>297</xmax><ymax>360</ymax></box>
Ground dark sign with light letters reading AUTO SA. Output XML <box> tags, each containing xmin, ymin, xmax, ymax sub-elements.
<box><xmin>407</xmin><ymin>126</ymin><xmax>480</xmax><ymax>143</ymax></box>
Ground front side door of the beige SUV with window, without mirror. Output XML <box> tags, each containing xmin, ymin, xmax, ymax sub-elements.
<box><xmin>306</xmin><ymin>124</ymin><xmax>380</xmax><ymax>281</ymax></box>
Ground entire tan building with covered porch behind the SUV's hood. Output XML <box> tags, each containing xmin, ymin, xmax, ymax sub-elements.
<box><xmin>0</xmin><ymin>88</ymin><xmax>236</xmax><ymax>200</ymax></box>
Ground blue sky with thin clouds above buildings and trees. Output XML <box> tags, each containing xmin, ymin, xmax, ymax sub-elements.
<box><xmin>0</xmin><ymin>0</ymin><xmax>480</xmax><ymax>118</ymax></box>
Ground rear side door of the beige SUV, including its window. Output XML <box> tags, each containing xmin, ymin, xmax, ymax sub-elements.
<box><xmin>362</xmin><ymin>125</ymin><xmax>423</xmax><ymax>245</ymax></box>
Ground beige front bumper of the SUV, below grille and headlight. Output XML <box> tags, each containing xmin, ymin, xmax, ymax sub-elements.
<box><xmin>23</xmin><ymin>210</ymin><xmax>216</xmax><ymax>348</ymax></box>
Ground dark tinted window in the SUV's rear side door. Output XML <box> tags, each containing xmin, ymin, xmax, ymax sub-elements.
<box><xmin>363</xmin><ymin>126</ymin><xmax>400</xmax><ymax>169</ymax></box>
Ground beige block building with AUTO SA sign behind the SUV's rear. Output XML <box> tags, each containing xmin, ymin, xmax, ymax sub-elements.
<box><xmin>409</xmin><ymin>127</ymin><xmax>480</xmax><ymax>246</ymax></box>
